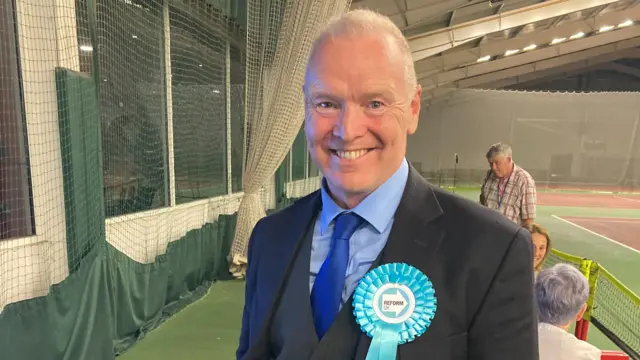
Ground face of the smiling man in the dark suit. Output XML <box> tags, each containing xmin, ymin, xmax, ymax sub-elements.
<box><xmin>305</xmin><ymin>35</ymin><xmax>421</xmax><ymax>207</ymax></box>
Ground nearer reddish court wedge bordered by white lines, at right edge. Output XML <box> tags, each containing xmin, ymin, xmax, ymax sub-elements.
<box><xmin>559</xmin><ymin>216</ymin><xmax>640</xmax><ymax>252</ymax></box>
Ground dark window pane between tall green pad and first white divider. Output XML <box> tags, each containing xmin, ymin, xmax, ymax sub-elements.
<box><xmin>96</xmin><ymin>0</ymin><xmax>169</xmax><ymax>216</ymax></box>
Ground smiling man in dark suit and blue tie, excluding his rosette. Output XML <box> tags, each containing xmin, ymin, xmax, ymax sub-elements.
<box><xmin>236</xmin><ymin>10</ymin><xmax>538</xmax><ymax>360</ymax></box>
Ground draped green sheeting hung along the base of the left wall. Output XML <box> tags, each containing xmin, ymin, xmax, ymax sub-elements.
<box><xmin>0</xmin><ymin>214</ymin><xmax>237</xmax><ymax>360</ymax></box>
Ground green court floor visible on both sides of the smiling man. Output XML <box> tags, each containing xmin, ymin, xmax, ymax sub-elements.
<box><xmin>119</xmin><ymin>191</ymin><xmax>640</xmax><ymax>360</ymax></box>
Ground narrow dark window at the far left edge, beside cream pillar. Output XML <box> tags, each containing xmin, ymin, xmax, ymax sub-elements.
<box><xmin>0</xmin><ymin>1</ymin><xmax>35</xmax><ymax>239</ymax></box>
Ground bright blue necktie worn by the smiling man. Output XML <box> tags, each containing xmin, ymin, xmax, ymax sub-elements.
<box><xmin>311</xmin><ymin>212</ymin><xmax>363</xmax><ymax>339</ymax></box>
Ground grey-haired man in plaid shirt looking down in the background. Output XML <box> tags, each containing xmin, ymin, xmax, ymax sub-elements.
<box><xmin>480</xmin><ymin>143</ymin><xmax>536</xmax><ymax>225</ymax></box>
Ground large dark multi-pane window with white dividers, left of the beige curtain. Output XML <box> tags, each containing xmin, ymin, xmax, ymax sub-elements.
<box><xmin>76</xmin><ymin>0</ymin><xmax>246</xmax><ymax>216</ymax></box>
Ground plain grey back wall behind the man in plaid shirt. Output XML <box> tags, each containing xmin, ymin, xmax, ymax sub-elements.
<box><xmin>407</xmin><ymin>90</ymin><xmax>640</xmax><ymax>186</ymax></box>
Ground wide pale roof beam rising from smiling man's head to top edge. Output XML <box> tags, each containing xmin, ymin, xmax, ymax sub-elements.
<box><xmin>408</xmin><ymin>0</ymin><xmax>617</xmax><ymax>61</ymax></box>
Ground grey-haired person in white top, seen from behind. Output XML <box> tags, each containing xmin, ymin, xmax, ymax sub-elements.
<box><xmin>534</xmin><ymin>264</ymin><xmax>602</xmax><ymax>360</ymax></box>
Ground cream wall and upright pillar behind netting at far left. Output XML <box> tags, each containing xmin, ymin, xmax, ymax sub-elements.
<box><xmin>0</xmin><ymin>0</ymin><xmax>79</xmax><ymax>309</ymax></box>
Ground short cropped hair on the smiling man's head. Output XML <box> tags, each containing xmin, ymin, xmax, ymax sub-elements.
<box><xmin>307</xmin><ymin>9</ymin><xmax>418</xmax><ymax>98</ymax></box>
